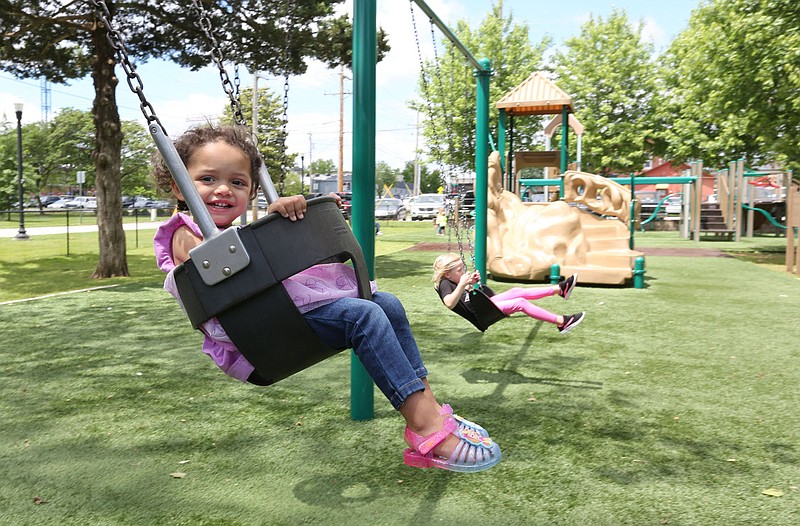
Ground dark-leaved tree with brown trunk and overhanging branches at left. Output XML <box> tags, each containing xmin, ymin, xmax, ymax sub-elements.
<box><xmin>0</xmin><ymin>0</ymin><xmax>385</xmax><ymax>278</ymax></box>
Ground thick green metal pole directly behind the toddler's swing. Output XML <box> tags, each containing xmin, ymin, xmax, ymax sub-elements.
<box><xmin>350</xmin><ymin>0</ymin><xmax>377</xmax><ymax>420</ymax></box>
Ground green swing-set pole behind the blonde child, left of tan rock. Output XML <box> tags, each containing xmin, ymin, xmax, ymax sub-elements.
<box><xmin>474</xmin><ymin>58</ymin><xmax>491</xmax><ymax>284</ymax></box>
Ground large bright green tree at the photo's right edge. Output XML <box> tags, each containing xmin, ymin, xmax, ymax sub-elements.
<box><xmin>661</xmin><ymin>0</ymin><xmax>800</xmax><ymax>178</ymax></box>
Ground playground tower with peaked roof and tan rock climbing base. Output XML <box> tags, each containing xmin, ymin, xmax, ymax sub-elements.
<box><xmin>490</xmin><ymin>72</ymin><xmax>643</xmax><ymax>285</ymax></box>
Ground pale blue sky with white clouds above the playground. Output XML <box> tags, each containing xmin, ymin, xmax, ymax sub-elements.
<box><xmin>0</xmin><ymin>0</ymin><xmax>701</xmax><ymax>170</ymax></box>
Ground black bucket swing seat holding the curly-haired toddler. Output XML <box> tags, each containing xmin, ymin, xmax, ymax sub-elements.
<box><xmin>175</xmin><ymin>197</ymin><xmax>372</xmax><ymax>385</ymax></box>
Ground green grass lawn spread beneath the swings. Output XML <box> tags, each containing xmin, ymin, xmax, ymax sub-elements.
<box><xmin>0</xmin><ymin>223</ymin><xmax>800</xmax><ymax>526</ymax></box>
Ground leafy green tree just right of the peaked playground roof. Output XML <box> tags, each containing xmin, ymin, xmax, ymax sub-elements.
<box><xmin>554</xmin><ymin>10</ymin><xmax>656</xmax><ymax>175</ymax></box>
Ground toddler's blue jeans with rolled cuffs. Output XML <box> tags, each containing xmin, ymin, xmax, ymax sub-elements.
<box><xmin>303</xmin><ymin>292</ymin><xmax>428</xmax><ymax>409</ymax></box>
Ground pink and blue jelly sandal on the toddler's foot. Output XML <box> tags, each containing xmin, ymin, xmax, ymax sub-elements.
<box><xmin>403</xmin><ymin>415</ymin><xmax>502</xmax><ymax>473</ymax></box>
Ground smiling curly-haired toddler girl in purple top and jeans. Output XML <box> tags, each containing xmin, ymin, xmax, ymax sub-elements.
<box><xmin>154</xmin><ymin>126</ymin><xmax>501</xmax><ymax>472</ymax></box>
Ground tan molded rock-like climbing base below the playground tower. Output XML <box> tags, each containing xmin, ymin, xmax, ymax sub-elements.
<box><xmin>487</xmin><ymin>152</ymin><xmax>643</xmax><ymax>285</ymax></box>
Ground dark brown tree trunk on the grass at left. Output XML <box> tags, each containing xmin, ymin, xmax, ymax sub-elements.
<box><xmin>92</xmin><ymin>16</ymin><xmax>128</xmax><ymax>279</ymax></box>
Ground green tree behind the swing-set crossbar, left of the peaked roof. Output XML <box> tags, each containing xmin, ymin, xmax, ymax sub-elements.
<box><xmin>411</xmin><ymin>0</ymin><xmax>550</xmax><ymax>172</ymax></box>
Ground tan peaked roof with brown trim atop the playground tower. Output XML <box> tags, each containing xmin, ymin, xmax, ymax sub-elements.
<box><xmin>495</xmin><ymin>71</ymin><xmax>575</xmax><ymax>115</ymax></box>
